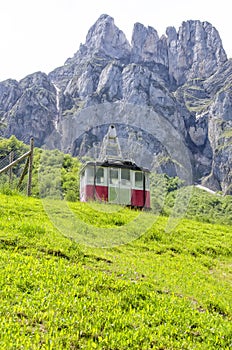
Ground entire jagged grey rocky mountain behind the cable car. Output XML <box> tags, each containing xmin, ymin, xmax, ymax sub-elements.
<box><xmin>0</xmin><ymin>15</ymin><xmax>232</xmax><ymax>194</ymax></box>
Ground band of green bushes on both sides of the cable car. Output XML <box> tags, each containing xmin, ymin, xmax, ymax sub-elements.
<box><xmin>0</xmin><ymin>136</ymin><xmax>232</xmax><ymax>225</ymax></box>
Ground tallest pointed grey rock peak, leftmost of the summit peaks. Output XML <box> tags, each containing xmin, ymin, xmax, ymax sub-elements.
<box><xmin>82</xmin><ymin>14</ymin><xmax>131</xmax><ymax>59</ymax></box>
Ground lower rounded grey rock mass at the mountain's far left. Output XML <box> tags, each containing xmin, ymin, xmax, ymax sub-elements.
<box><xmin>0</xmin><ymin>72</ymin><xmax>57</xmax><ymax>146</ymax></box>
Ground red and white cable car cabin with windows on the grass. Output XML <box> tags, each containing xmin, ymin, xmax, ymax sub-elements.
<box><xmin>80</xmin><ymin>160</ymin><xmax>150</xmax><ymax>209</ymax></box>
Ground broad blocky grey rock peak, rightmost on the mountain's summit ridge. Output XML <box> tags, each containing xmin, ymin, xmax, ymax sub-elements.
<box><xmin>166</xmin><ymin>20</ymin><xmax>227</xmax><ymax>85</ymax></box>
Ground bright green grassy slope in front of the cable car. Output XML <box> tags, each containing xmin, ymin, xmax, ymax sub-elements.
<box><xmin>0</xmin><ymin>195</ymin><xmax>232</xmax><ymax>350</ymax></box>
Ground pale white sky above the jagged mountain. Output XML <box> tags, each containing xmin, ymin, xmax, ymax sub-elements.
<box><xmin>0</xmin><ymin>0</ymin><xmax>232</xmax><ymax>81</ymax></box>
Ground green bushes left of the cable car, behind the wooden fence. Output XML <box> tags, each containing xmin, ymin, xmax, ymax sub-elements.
<box><xmin>0</xmin><ymin>136</ymin><xmax>81</xmax><ymax>201</ymax></box>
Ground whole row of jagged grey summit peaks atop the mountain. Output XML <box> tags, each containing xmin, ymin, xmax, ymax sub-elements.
<box><xmin>62</xmin><ymin>14</ymin><xmax>227</xmax><ymax>86</ymax></box>
